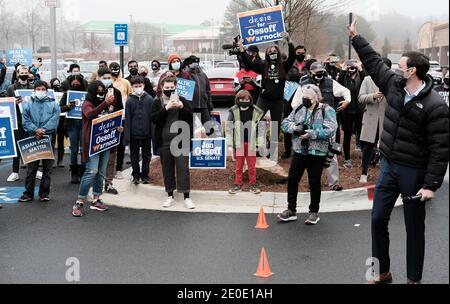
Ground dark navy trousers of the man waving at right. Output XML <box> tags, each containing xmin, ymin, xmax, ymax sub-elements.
<box><xmin>372</xmin><ymin>158</ymin><xmax>426</xmax><ymax>281</ymax></box>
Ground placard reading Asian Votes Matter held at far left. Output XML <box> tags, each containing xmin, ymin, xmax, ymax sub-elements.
<box><xmin>17</xmin><ymin>135</ymin><xmax>55</xmax><ymax>165</ymax></box>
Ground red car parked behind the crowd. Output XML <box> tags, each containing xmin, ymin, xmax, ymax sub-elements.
<box><xmin>206</xmin><ymin>68</ymin><xmax>239</xmax><ymax>105</ymax></box>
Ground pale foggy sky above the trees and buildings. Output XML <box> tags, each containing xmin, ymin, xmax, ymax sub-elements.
<box><xmin>6</xmin><ymin>0</ymin><xmax>449</xmax><ymax>24</ymax></box>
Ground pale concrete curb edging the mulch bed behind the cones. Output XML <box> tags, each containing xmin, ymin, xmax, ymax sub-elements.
<box><xmin>104</xmin><ymin>169</ymin><xmax>403</xmax><ymax>214</ymax></box>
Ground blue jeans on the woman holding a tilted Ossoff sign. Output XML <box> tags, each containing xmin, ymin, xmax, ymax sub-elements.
<box><xmin>78</xmin><ymin>150</ymin><xmax>111</xmax><ymax>202</ymax></box>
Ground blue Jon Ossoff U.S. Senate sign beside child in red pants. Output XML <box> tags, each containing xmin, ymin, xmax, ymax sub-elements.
<box><xmin>189</xmin><ymin>138</ymin><xmax>227</xmax><ymax>169</ymax></box>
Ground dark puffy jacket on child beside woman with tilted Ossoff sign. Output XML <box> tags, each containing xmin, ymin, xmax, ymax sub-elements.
<box><xmin>123</xmin><ymin>92</ymin><xmax>153</xmax><ymax>146</ymax></box>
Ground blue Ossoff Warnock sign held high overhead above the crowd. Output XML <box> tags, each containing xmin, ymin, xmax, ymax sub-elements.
<box><xmin>238</xmin><ymin>5</ymin><xmax>286</xmax><ymax>46</ymax></box>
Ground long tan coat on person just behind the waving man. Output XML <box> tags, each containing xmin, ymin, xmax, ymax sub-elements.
<box><xmin>359</xmin><ymin>76</ymin><xmax>386</xmax><ymax>144</ymax></box>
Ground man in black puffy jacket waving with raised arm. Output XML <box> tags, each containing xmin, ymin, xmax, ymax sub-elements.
<box><xmin>348</xmin><ymin>21</ymin><xmax>449</xmax><ymax>284</ymax></box>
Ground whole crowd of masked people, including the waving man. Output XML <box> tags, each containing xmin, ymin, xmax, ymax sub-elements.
<box><xmin>0</xmin><ymin>20</ymin><xmax>449</xmax><ymax>283</ymax></box>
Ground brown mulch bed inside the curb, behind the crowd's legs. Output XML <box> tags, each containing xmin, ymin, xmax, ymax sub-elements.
<box><xmin>150</xmin><ymin>143</ymin><xmax>379</xmax><ymax>193</ymax></box>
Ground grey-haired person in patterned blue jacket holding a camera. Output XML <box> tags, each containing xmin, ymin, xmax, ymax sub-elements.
<box><xmin>278</xmin><ymin>85</ymin><xmax>337</xmax><ymax>225</ymax></box>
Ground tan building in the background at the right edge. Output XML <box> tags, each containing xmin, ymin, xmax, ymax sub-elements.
<box><xmin>417</xmin><ymin>21</ymin><xmax>449</xmax><ymax>67</ymax></box>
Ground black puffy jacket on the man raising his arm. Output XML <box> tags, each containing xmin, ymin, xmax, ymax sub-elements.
<box><xmin>353</xmin><ymin>36</ymin><xmax>449</xmax><ymax>191</ymax></box>
